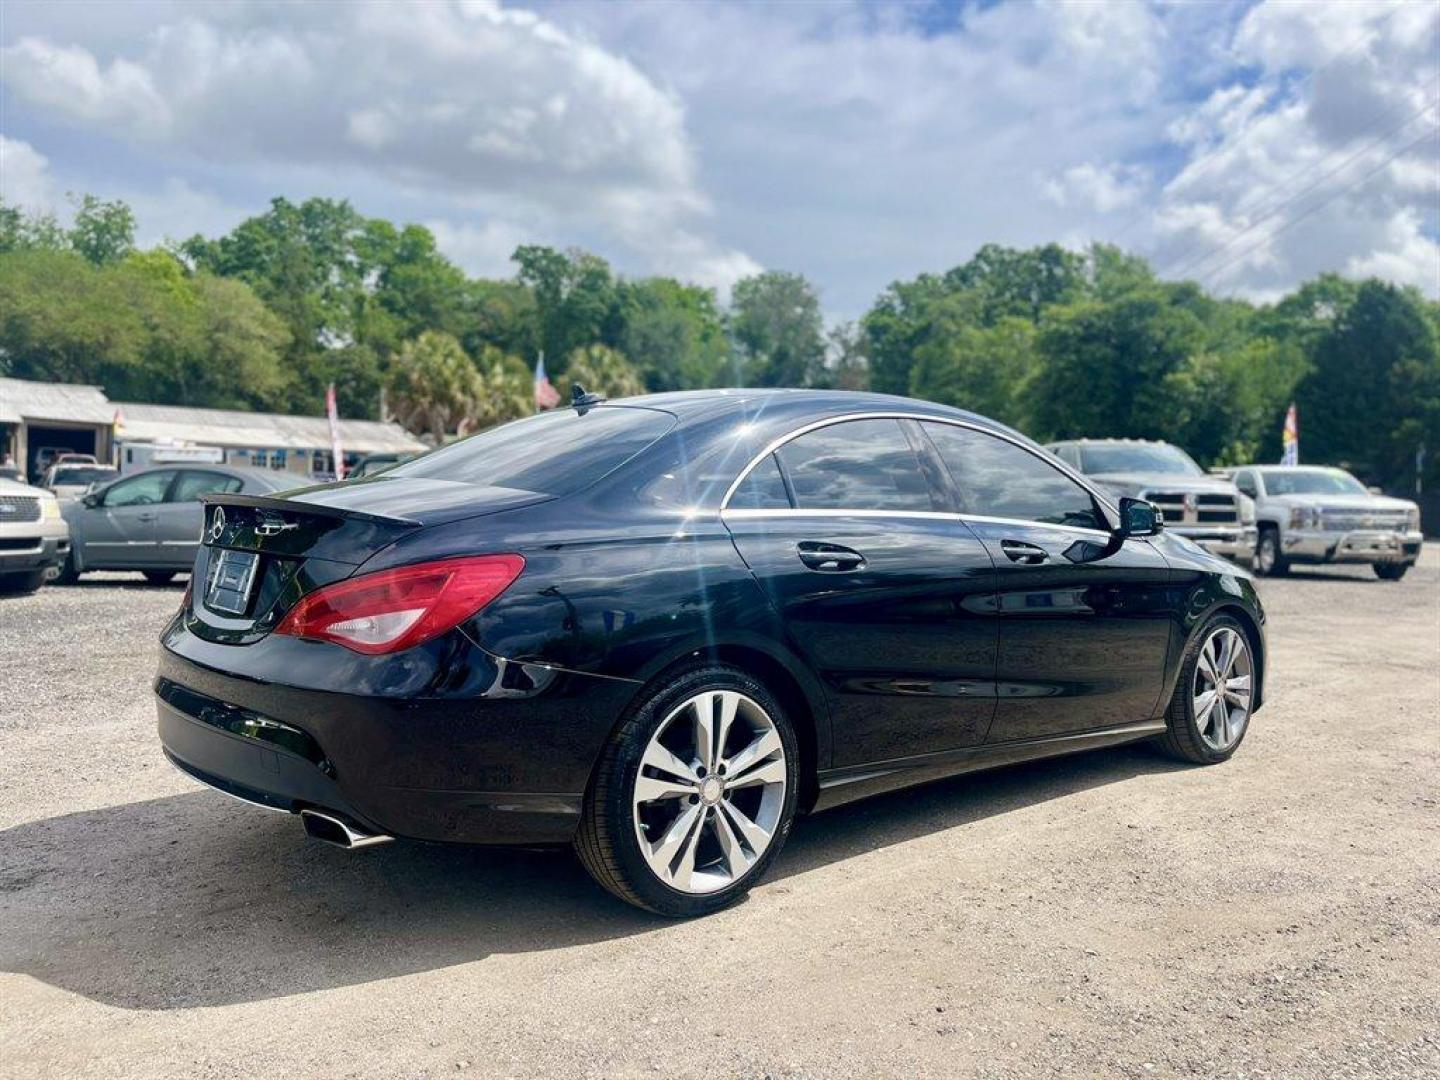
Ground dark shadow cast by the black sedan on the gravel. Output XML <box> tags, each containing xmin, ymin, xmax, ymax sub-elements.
<box><xmin>0</xmin><ymin>747</ymin><xmax>1174</xmax><ymax>1009</ymax></box>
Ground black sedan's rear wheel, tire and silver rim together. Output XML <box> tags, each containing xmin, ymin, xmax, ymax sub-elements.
<box><xmin>575</xmin><ymin>664</ymin><xmax>799</xmax><ymax>917</ymax></box>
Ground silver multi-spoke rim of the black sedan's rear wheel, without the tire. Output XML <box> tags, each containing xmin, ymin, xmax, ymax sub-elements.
<box><xmin>632</xmin><ymin>690</ymin><xmax>788</xmax><ymax>894</ymax></box>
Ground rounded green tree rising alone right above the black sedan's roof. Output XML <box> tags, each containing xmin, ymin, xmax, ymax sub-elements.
<box><xmin>730</xmin><ymin>271</ymin><xmax>825</xmax><ymax>386</ymax></box>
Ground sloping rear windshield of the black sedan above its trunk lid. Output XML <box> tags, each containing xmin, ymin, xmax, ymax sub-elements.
<box><xmin>384</xmin><ymin>406</ymin><xmax>675</xmax><ymax>495</ymax></box>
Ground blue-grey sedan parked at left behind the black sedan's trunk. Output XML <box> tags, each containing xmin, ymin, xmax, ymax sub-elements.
<box><xmin>58</xmin><ymin>465</ymin><xmax>294</xmax><ymax>585</ymax></box>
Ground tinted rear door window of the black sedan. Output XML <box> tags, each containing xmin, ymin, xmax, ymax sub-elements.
<box><xmin>776</xmin><ymin>420</ymin><xmax>943</xmax><ymax>511</ymax></box>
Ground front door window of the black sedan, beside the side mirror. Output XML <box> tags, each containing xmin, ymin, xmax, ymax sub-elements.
<box><xmin>924</xmin><ymin>422</ymin><xmax>1104</xmax><ymax>530</ymax></box>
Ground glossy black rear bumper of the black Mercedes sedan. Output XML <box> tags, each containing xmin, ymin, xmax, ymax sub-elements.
<box><xmin>156</xmin><ymin>621</ymin><xmax>634</xmax><ymax>844</ymax></box>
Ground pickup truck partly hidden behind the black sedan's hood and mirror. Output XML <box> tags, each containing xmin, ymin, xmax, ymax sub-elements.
<box><xmin>1048</xmin><ymin>439</ymin><xmax>1259</xmax><ymax>564</ymax></box>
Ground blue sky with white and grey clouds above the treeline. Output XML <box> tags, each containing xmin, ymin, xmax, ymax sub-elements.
<box><xmin>0</xmin><ymin>0</ymin><xmax>1440</xmax><ymax>320</ymax></box>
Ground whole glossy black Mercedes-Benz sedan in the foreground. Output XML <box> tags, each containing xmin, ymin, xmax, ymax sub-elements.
<box><xmin>156</xmin><ymin>390</ymin><xmax>1266</xmax><ymax>916</ymax></box>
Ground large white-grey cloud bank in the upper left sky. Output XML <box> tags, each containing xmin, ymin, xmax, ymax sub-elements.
<box><xmin>0</xmin><ymin>0</ymin><xmax>744</xmax><ymax>283</ymax></box>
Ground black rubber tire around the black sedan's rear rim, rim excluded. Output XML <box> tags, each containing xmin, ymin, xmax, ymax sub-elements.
<box><xmin>575</xmin><ymin>664</ymin><xmax>799</xmax><ymax>919</ymax></box>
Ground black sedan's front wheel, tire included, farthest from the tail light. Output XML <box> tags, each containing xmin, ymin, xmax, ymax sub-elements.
<box><xmin>1159</xmin><ymin>615</ymin><xmax>1257</xmax><ymax>765</ymax></box>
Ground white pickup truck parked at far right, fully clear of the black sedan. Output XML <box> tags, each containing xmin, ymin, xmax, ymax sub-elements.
<box><xmin>1234</xmin><ymin>465</ymin><xmax>1424</xmax><ymax>582</ymax></box>
